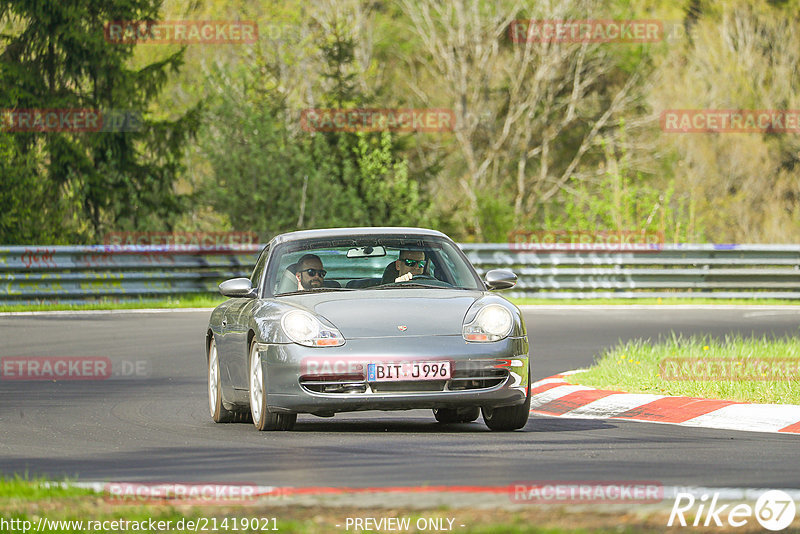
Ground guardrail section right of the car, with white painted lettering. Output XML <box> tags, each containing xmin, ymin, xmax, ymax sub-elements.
<box><xmin>462</xmin><ymin>244</ymin><xmax>800</xmax><ymax>299</ymax></box>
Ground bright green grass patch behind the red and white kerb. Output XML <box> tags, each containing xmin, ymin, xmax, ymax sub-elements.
<box><xmin>568</xmin><ymin>335</ymin><xmax>800</xmax><ymax>404</ymax></box>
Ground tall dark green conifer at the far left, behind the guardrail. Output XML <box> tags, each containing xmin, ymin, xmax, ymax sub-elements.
<box><xmin>0</xmin><ymin>0</ymin><xmax>198</xmax><ymax>243</ymax></box>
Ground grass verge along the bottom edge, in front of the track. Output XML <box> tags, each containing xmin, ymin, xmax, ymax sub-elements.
<box><xmin>0</xmin><ymin>477</ymin><xmax>692</xmax><ymax>534</ymax></box>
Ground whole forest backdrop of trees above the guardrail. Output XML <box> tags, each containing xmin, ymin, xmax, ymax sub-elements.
<box><xmin>0</xmin><ymin>0</ymin><xmax>800</xmax><ymax>245</ymax></box>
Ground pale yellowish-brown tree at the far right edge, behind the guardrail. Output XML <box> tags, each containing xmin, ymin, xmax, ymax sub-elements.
<box><xmin>649</xmin><ymin>1</ymin><xmax>800</xmax><ymax>243</ymax></box>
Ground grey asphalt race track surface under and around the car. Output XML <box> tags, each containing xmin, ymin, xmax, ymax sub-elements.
<box><xmin>0</xmin><ymin>308</ymin><xmax>800</xmax><ymax>488</ymax></box>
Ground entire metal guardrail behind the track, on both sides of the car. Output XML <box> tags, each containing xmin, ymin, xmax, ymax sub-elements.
<box><xmin>0</xmin><ymin>244</ymin><xmax>800</xmax><ymax>304</ymax></box>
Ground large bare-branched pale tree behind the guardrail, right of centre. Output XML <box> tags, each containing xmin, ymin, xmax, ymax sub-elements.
<box><xmin>400</xmin><ymin>0</ymin><xmax>650</xmax><ymax>240</ymax></box>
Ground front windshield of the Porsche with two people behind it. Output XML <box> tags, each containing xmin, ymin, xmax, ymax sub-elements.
<box><xmin>266</xmin><ymin>235</ymin><xmax>484</xmax><ymax>295</ymax></box>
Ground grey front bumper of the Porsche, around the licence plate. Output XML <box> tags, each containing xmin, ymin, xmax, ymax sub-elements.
<box><xmin>257</xmin><ymin>335</ymin><xmax>529</xmax><ymax>415</ymax></box>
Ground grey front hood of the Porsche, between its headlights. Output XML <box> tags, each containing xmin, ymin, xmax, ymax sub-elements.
<box><xmin>282</xmin><ymin>289</ymin><xmax>484</xmax><ymax>339</ymax></box>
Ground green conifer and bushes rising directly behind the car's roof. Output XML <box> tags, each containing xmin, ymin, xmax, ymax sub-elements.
<box><xmin>200</xmin><ymin>18</ymin><xmax>430</xmax><ymax>239</ymax></box>
